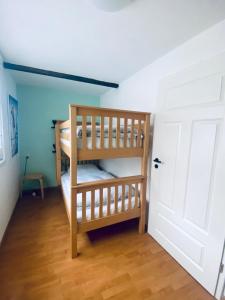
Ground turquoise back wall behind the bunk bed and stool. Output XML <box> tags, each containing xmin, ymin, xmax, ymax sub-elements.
<box><xmin>17</xmin><ymin>85</ymin><xmax>100</xmax><ymax>188</ymax></box>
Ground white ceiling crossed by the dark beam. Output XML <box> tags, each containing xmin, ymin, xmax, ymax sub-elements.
<box><xmin>0</xmin><ymin>0</ymin><xmax>225</xmax><ymax>95</ymax></box>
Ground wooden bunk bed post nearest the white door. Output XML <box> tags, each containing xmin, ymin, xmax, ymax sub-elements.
<box><xmin>139</xmin><ymin>114</ymin><xmax>150</xmax><ymax>233</ymax></box>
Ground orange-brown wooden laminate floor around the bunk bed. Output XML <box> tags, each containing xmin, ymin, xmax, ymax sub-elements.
<box><xmin>0</xmin><ymin>190</ymin><xmax>212</xmax><ymax>300</ymax></box>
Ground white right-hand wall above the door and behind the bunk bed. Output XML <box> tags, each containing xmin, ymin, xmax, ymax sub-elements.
<box><xmin>101</xmin><ymin>20</ymin><xmax>225</xmax><ymax>192</ymax></box>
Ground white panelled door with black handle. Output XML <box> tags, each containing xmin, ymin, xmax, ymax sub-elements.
<box><xmin>148</xmin><ymin>53</ymin><xmax>225</xmax><ymax>294</ymax></box>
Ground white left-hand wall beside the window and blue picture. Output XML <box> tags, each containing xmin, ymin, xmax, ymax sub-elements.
<box><xmin>0</xmin><ymin>54</ymin><xmax>19</xmax><ymax>242</ymax></box>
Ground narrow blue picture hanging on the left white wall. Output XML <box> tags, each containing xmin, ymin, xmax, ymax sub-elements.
<box><xmin>9</xmin><ymin>95</ymin><xmax>18</xmax><ymax>157</ymax></box>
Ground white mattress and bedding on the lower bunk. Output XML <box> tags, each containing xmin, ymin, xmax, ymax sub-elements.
<box><xmin>61</xmin><ymin>164</ymin><xmax>140</xmax><ymax>222</ymax></box>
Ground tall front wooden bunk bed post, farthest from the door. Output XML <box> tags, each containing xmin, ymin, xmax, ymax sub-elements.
<box><xmin>70</xmin><ymin>105</ymin><xmax>77</xmax><ymax>258</ymax></box>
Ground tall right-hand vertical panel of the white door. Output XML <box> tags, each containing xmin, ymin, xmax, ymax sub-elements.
<box><xmin>184</xmin><ymin>120</ymin><xmax>218</xmax><ymax>229</ymax></box>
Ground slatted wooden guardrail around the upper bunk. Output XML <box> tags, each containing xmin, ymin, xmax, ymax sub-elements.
<box><xmin>60</xmin><ymin>105</ymin><xmax>148</xmax><ymax>160</ymax></box>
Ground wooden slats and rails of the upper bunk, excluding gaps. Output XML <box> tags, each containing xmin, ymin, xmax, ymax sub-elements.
<box><xmin>59</xmin><ymin>104</ymin><xmax>150</xmax><ymax>160</ymax></box>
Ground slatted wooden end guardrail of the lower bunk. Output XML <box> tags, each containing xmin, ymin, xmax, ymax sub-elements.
<box><xmin>73</xmin><ymin>175</ymin><xmax>144</xmax><ymax>232</ymax></box>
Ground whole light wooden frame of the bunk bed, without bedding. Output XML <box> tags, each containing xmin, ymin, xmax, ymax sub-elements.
<box><xmin>56</xmin><ymin>104</ymin><xmax>150</xmax><ymax>258</ymax></box>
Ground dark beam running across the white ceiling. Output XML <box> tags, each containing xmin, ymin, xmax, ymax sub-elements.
<box><xmin>3</xmin><ymin>62</ymin><xmax>119</xmax><ymax>89</ymax></box>
